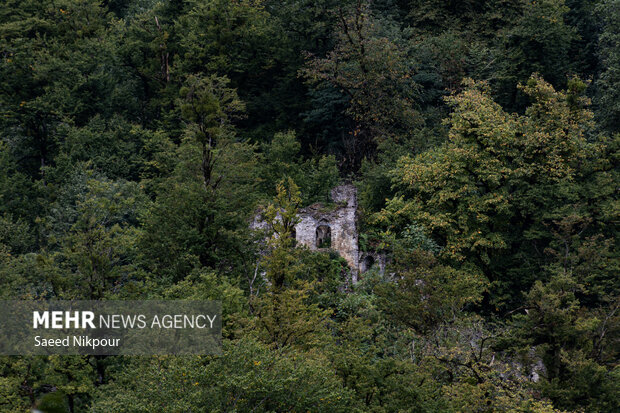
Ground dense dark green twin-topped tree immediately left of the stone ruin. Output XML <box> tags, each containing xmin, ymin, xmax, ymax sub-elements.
<box><xmin>139</xmin><ymin>137</ymin><xmax>258</xmax><ymax>281</ymax></box>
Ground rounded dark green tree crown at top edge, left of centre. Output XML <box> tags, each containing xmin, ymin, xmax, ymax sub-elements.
<box><xmin>173</xmin><ymin>0</ymin><xmax>294</xmax><ymax>141</ymax></box>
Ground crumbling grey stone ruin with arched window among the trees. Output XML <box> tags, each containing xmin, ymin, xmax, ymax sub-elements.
<box><xmin>252</xmin><ymin>184</ymin><xmax>386</xmax><ymax>283</ymax></box>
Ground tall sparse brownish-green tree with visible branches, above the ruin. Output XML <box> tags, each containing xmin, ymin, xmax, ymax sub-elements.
<box><xmin>302</xmin><ymin>1</ymin><xmax>417</xmax><ymax>170</ymax></box>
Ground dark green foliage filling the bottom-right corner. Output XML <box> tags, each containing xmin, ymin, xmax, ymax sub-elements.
<box><xmin>513</xmin><ymin>273</ymin><xmax>620</xmax><ymax>412</ymax></box>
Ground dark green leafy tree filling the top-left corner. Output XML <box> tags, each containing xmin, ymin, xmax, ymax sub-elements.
<box><xmin>0</xmin><ymin>0</ymin><xmax>116</xmax><ymax>178</ymax></box>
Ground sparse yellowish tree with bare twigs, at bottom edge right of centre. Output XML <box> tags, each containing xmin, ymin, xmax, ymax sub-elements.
<box><xmin>412</xmin><ymin>316</ymin><xmax>560</xmax><ymax>413</ymax></box>
